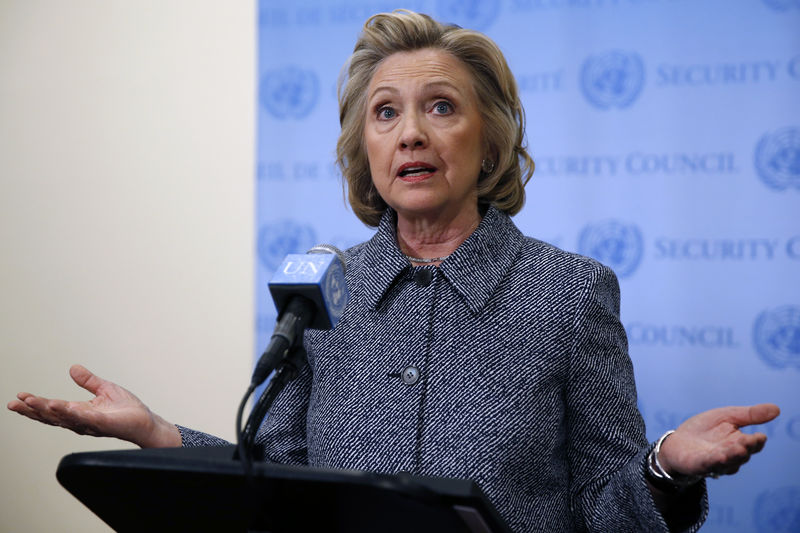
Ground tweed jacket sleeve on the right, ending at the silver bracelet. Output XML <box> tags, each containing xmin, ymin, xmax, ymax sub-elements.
<box><xmin>567</xmin><ymin>261</ymin><xmax>708</xmax><ymax>533</ymax></box>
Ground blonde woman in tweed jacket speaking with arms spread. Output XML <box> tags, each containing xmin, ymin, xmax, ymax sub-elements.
<box><xmin>9</xmin><ymin>11</ymin><xmax>778</xmax><ymax>531</ymax></box>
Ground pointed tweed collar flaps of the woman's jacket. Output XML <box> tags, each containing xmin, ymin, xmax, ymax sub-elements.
<box><xmin>359</xmin><ymin>206</ymin><xmax>525</xmax><ymax>314</ymax></box>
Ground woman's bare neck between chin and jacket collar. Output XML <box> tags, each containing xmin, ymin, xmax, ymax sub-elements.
<box><xmin>397</xmin><ymin>205</ymin><xmax>481</xmax><ymax>264</ymax></box>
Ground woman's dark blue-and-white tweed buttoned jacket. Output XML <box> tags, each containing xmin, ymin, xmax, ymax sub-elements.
<box><xmin>180</xmin><ymin>207</ymin><xmax>707</xmax><ymax>533</ymax></box>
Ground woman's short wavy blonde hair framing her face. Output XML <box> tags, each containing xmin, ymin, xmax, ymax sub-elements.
<box><xmin>336</xmin><ymin>9</ymin><xmax>534</xmax><ymax>226</ymax></box>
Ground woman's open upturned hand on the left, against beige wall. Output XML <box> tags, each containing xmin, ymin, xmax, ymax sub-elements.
<box><xmin>8</xmin><ymin>365</ymin><xmax>181</xmax><ymax>448</ymax></box>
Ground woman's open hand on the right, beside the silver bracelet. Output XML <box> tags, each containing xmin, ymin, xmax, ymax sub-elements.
<box><xmin>658</xmin><ymin>403</ymin><xmax>780</xmax><ymax>476</ymax></box>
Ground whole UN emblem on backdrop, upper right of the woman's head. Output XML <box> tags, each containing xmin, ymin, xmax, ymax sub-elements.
<box><xmin>581</xmin><ymin>50</ymin><xmax>644</xmax><ymax>109</ymax></box>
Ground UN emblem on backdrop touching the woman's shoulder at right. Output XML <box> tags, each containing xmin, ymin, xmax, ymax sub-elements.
<box><xmin>578</xmin><ymin>220</ymin><xmax>644</xmax><ymax>278</ymax></box>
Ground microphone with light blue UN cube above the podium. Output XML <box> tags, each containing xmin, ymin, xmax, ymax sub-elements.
<box><xmin>250</xmin><ymin>244</ymin><xmax>350</xmax><ymax>387</ymax></box>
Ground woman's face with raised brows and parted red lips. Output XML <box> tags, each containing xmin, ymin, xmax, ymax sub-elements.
<box><xmin>364</xmin><ymin>49</ymin><xmax>486</xmax><ymax>220</ymax></box>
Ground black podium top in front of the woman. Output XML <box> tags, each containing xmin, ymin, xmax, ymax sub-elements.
<box><xmin>56</xmin><ymin>446</ymin><xmax>509</xmax><ymax>533</ymax></box>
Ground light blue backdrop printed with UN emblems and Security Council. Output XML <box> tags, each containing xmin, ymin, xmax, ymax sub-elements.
<box><xmin>256</xmin><ymin>0</ymin><xmax>800</xmax><ymax>533</ymax></box>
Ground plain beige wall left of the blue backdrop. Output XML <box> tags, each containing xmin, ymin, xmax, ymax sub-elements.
<box><xmin>0</xmin><ymin>0</ymin><xmax>256</xmax><ymax>532</ymax></box>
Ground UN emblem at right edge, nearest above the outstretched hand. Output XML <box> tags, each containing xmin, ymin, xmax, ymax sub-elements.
<box><xmin>753</xmin><ymin>305</ymin><xmax>800</xmax><ymax>369</ymax></box>
